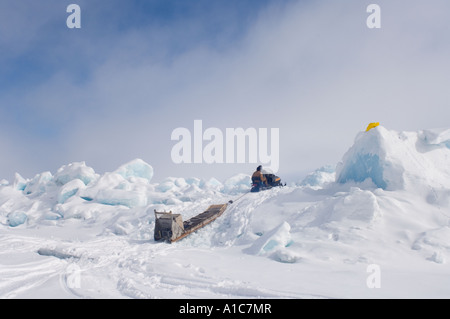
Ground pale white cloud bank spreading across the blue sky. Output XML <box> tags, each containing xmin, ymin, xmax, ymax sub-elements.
<box><xmin>0</xmin><ymin>0</ymin><xmax>450</xmax><ymax>179</ymax></box>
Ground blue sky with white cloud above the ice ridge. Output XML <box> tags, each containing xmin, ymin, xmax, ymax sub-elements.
<box><xmin>0</xmin><ymin>0</ymin><xmax>450</xmax><ymax>182</ymax></box>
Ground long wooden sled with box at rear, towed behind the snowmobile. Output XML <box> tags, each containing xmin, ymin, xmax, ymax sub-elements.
<box><xmin>154</xmin><ymin>204</ymin><xmax>227</xmax><ymax>243</ymax></box>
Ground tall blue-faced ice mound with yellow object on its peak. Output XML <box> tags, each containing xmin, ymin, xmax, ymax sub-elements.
<box><xmin>336</xmin><ymin>126</ymin><xmax>450</xmax><ymax>190</ymax></box>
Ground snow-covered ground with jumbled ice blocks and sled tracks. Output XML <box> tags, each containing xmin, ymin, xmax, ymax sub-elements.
<box><xmin>0</xmin><ymin>126</ymin><xmax>450</xmax><ymax>298</ymax></box>
